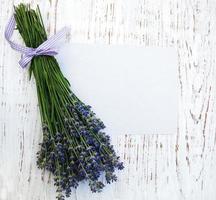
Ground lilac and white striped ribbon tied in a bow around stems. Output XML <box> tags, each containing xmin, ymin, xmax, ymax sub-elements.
<box><xmin>5</xmin><ymin>15</ymin><xmax>70</xmax><ymax>68</ymax></box>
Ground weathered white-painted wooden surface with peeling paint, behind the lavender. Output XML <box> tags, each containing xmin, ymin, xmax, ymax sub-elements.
<box><xmin>0</xmin><ymin>0</ymin><xmax>216</xmax><ymax>200</ymax></box>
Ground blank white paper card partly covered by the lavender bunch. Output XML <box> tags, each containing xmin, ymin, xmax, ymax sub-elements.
<box><xmin>57</xmin><ymin>44</ymin><xmax>178</xmax><ymax>135</ymax></box>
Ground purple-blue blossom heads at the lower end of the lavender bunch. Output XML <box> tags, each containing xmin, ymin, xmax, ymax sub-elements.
<box><xmin>38</xmin><ymin>99</ymin><xmax>123</xmax><ymax>200</ymax></box>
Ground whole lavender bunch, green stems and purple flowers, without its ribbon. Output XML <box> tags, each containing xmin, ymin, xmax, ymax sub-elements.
<box><xmin>14</xmin><ymin>4</ymin><xmax>123</xmax><ymax>200</ymax></box>
